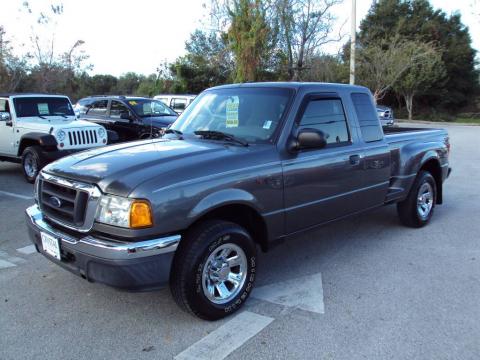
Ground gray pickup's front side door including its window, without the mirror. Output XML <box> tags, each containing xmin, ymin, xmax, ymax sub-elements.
<box><xmin>282</xmin><ymin>93</ymin><xmax>388</xmax><ymax>233</ymax></box>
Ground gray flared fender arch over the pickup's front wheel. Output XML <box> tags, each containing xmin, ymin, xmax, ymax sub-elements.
<box><xmin>188</xmin><ymin>188</ymin><xmax>263</xmax><ymax>222</ymax></box>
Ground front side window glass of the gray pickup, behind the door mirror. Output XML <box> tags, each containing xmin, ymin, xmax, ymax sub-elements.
<box><xmin>299</xmin><ymin>99</ymin><xmax>350</xmax><ymax>146</ymax></box>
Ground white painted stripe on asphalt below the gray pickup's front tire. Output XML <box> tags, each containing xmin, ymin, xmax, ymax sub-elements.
<box><xmin>175</xmin><ymin>311</ymin><xmax>274</xmax><ymax>360</ymax></box>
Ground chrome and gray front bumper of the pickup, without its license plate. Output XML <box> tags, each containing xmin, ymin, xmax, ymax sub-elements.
<box><xmin>26</xmin><ymin>205</ymin><xmax>181</xmax><ymax>291</ymax></box>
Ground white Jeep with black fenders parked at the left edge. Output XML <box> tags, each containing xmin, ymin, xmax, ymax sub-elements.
<box><xmin>0</xmin><ymin>94</ymin><xmax>108</xmax><ymax>182</ymax></box>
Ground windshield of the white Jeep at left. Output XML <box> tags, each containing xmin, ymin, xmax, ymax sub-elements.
<box><xmin>13</xmin><ymin>97</ymin><xmax>75</xmax><ymax>117</ymax></box>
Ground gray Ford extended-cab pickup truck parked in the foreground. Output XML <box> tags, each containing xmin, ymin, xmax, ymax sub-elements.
<box><xmin>26</xmin><ymin>83</ymin><xmax>450</xmax><ymax>320</ymax></box>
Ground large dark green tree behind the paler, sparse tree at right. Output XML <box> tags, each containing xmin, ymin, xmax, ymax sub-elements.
<box><xmin>358</xmin><ymin>0</ymin><xmax>479</xmax><ymax>109</ymax></box>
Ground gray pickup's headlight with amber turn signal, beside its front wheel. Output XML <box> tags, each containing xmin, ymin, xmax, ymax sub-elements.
<box><xmin>96</xmin><ymin>195</ymin><xmax>153</xmax><ymax>229</ymax></box>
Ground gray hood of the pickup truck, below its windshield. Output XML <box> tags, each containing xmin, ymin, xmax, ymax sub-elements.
<box><xmin>43</xmin><ymin>139</ymin><xmax>253</xmax><ymax>196</ymax></box>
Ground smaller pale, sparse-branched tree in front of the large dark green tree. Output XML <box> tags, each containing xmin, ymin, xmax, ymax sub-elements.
<box><xmin>357</xmin><ymin>37</ymin><xmax>442</xmax><ymax>101</ymax></box>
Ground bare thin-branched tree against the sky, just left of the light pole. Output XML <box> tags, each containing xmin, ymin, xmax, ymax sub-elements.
<box><xmin>275</xmin><ymin>0</ymin><xmax>343</xmax><ymax>80</ymax></box>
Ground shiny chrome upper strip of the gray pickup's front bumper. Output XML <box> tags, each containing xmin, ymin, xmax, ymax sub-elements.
<box><xmin>26</xmin><ymin>205</ymin><xmax>181</xmax><ymax>260</ymax></box>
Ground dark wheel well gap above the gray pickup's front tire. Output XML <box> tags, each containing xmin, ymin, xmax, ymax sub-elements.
<box><xmin>188</xmin><ymin>204</ymin><xmax>268</xmax><ymax>251</ymax></box>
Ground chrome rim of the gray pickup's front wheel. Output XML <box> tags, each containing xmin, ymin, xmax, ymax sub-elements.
<box><xmin>202</xmin><ymin>243</ymin><xmax>247</xmax><ymax>304</ymax></box>
